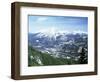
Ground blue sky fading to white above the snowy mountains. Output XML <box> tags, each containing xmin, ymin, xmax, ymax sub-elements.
<box><xmin>28</xmin><ymin>15</ymin><xmax>88</xmax><ymax>33</ymax></box>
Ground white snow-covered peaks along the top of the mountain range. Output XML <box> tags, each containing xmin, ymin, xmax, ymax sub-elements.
<box><xmin>32</xmin><ymin>28</ymin><xmax>87</xmax><ymax>38</ymax></box>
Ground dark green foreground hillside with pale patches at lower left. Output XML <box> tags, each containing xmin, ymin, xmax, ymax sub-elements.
<box><xmin>28</xmin><ymin>46</ymin><xmax>77</xmax><ymax>66</ymax></box>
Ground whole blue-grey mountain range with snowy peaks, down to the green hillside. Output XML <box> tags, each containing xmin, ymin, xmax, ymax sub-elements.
<box><xmin>28</xmin><ymin>29</ymin><xmax>88</xmax><ymax>57</ymax></box>
